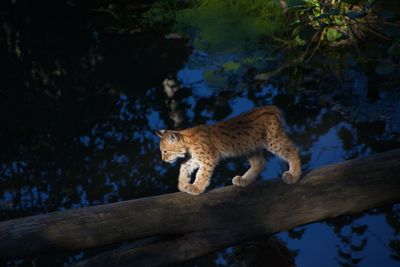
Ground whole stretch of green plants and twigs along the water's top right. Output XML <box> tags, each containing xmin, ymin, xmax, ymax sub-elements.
<box><xmin>140</xmin><ymin>0</ymin><xmax>400</xmax><ymax>88</ymax></box>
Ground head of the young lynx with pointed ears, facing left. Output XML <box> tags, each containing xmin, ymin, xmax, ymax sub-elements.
<box><xmin>155</xmin><ymin>130</ymin><xmax>187</xmax><ymax>163</ymax></box>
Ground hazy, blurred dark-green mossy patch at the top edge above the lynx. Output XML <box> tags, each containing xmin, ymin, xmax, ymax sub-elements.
<box><xmin>176</xmin><ymin>0</ymin><xmax>284</xmax><ymax>52</ymax></box>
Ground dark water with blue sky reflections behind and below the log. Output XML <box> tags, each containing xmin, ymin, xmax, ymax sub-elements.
<box><xmin>0</xmin><ymin>1</ymin><xmax>400</xmax><ymax>266</ymax></box>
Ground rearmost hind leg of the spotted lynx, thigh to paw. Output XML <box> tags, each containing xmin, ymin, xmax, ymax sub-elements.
<box><xmin>267</xmin><ymin>132</ymin><xmax>301</xmax><ymax>184</ymax></box>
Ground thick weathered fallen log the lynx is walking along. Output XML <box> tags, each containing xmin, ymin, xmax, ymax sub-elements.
<box><xmin>0</xmin><ymin>149</ymin><xmax>400</xmax><ymax>266</ymax></box>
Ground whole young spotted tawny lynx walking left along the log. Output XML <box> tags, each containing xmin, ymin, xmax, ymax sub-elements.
<box><xmin>156</xmin><ymin>106</ymin><xmax>301</xmax><ymax>195</ymax></box>
